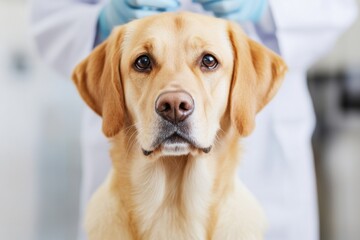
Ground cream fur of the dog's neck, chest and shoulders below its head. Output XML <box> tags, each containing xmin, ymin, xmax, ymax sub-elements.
<box><xmin>85</xmin><ymin>128</ymin><xmax>266</xmax><ymax>240</ymax></box>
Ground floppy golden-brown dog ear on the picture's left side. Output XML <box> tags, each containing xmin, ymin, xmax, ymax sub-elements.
<box><xmin>72</xmin><ymin>27</ymin><xmax>125</xmax><ymax>137</ymax></box>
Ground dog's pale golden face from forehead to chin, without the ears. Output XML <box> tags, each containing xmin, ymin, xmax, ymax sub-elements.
<box><xmin>120</xmin><ymin>15</ymin><xmax>234</xmax><ymax>158</ymax></box>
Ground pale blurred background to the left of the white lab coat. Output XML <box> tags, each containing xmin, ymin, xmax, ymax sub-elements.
<box><xmin>0</xmin><ymin>0</ymin><xmax>82</xmax><ymax>240</ymax></box>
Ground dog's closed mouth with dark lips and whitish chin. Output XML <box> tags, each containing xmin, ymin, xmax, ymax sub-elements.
<box><xmin>142</xmin><ymin>125</ymin><xmax>212</xmax><ymax>156</ymax></box>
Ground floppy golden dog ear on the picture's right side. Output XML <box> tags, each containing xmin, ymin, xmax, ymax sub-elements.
<box><xmin>228</xmin><ymin>22</ymin><xmax>287</xmax><ymax>136</ymax></box>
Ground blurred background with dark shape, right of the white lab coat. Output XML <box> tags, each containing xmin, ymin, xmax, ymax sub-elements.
<box><xmin>308</xmin><ymin>0</ymin><xmax>360</xmax><ymax>240</ymax></box>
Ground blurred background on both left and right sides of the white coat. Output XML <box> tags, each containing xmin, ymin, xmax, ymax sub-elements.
<box><xmin>0</xmin><ymin>0</ymin><xmax>360</xmax><ymax>240</ymax></box>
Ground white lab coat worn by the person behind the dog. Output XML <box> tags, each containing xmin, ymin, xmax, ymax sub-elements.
<box><xmin>31</xmin><ymin>0</ymin><xmax>357</xmax><ymax>240</ymax></box>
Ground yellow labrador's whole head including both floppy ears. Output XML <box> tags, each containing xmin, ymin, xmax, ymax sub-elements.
<box><xmin>73</xmin><ymin>13</ymin><xmax>286</xmax><ymax>156</ymax></box>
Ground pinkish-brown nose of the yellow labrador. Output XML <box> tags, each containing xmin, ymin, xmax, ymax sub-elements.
<box><xmin>155</xmin><ymin>91</ymin><xmax>194</xmax><ymax>124</ymax></box>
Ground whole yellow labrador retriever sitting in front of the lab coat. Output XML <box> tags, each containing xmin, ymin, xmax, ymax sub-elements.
<box><xmin>73</xmin><ymin>13</ymin><xmax>286</xmax><ymax>240</ymax></box>
